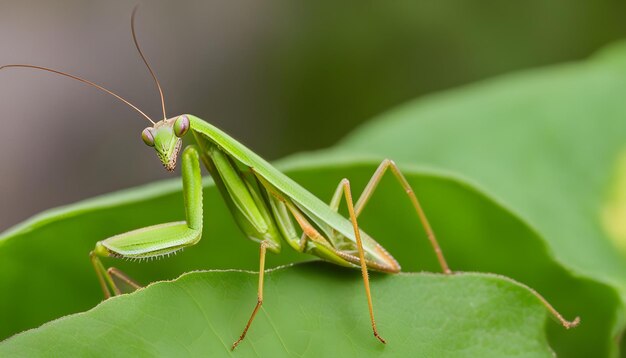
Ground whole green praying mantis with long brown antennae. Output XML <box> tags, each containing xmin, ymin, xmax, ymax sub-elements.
<box><xmin>0</xmin><ymin>7</ymin><xmax>580</xmax><ymax>349</ymax></box>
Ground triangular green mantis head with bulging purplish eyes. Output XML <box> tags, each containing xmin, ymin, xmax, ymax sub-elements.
<box><xmin>141</xmin><ymin>115</ymin><xmax>189</xmax><ymax>172</ymax></box>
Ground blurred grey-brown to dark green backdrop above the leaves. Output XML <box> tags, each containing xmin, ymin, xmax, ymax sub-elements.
<box><xmin>0</xmin><ymin>0</ymin><xmax>626</xmax><ymax>231</ymax></box>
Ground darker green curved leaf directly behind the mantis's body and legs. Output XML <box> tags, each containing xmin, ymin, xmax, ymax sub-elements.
<box><xmin>0</xmin><ymin>162</ymin><xmax>619</xmax><ymax>356</ymax></box>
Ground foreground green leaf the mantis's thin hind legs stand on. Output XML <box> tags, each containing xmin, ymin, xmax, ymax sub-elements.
<box><xmin>0</xmin><ymin>263</ymin><xmax>552</xmax><ymax>357</ymax></box>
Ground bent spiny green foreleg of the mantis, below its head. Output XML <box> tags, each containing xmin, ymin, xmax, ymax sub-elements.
<box><xmin>90</xmin><ymin>146</ymin><xmax>202</xmax><ymax>298</ymax></box>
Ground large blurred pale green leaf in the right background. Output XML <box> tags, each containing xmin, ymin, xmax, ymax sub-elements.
<box><xmin>335</xmin><ymin>39</ymin><xmax>626</xmax><ymax>296</ymax></box>
